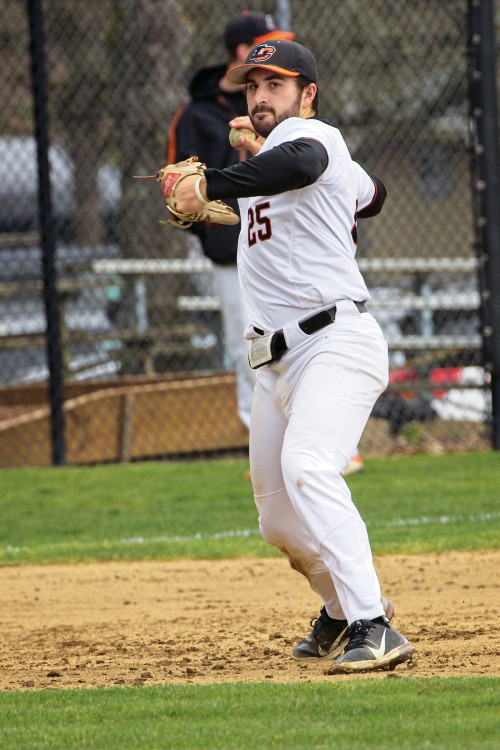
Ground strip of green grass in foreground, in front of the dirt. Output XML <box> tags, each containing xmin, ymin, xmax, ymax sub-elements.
<box><xmin>0</xmin><ymin>678</ymin><xmax>500</xmax><ymax>750</ymax></box>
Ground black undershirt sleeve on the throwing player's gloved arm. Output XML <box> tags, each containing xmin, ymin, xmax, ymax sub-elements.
<box><xmin>205</xmin><ymin>138</ymin><xmax>328</xmax><ymax>200</ymax></box>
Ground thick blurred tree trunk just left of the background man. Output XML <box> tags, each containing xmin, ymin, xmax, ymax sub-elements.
<box><xmin>106</xmin><ymin>0</ymin><xmax>191</xmax><ymax>257</ymax></box>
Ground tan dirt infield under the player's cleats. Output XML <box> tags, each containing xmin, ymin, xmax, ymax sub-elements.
<box><xmin>0</xmin><ymin>550</ymin><xmax>500</xmax><ymax>690</ymax></box>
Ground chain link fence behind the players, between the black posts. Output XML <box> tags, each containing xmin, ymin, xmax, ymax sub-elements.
<box><xmin>0</xmin><ymin>0</ymin><xmax>491</xmax><ymax>466</ymax></box>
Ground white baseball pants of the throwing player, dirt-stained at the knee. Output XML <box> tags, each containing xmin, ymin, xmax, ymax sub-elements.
<box><xmin>250</xmin><ymin>300</ymin><xmax>388</xmax><ymax>624</ymax></box>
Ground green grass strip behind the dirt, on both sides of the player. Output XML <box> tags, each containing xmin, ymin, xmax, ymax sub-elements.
<box><xmin>0</xmin><ymin>451</ymin><xmax>500</xmax><ymax>564</ymax></box>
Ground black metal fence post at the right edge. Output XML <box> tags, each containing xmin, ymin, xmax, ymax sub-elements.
<box><xmin>468</xmin><ymin>0</ymin><xmax>500</xmax><ymax>450</ymax></box>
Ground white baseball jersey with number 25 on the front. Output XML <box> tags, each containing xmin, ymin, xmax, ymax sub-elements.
<box><xmin>238</xmin><ymin>117</ymin><xmax>375</xmax><ymax>337</ymax></box>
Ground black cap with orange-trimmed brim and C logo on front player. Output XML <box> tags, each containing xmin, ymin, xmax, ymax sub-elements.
<box><xmin>227</xmin><ymin>39</ymin><xmax>318</xmax><ymax>83</ymax></box>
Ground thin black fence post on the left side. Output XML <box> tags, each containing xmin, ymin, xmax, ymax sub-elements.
<box><xmin>28</xmin><ymin>0</ymin><xmax>66</xmax><ymax>466</ymax></box>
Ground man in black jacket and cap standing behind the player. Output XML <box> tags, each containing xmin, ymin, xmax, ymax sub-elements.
<box><xmin>167</xmin><ymin>11</ymin><xmax>295</xmax><ymax>428</ymax></box>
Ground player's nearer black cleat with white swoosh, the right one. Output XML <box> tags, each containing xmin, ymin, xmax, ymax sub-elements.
<box><xmin>329</xmin><ymin>617</ymin><xmax>415</xmax><ymax>674</ymax></box>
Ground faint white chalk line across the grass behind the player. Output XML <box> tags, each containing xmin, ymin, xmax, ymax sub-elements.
<box><xmin>0</xmin><ymin>512</ymin><xmax>500</xmax><ymax>554</ymax></box>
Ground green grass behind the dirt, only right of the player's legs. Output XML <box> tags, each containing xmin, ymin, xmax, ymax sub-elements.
<box><xmin>349</xmin><ymin>452</ymin><xmax>500</xmax><ymax>554</ymax></box>
